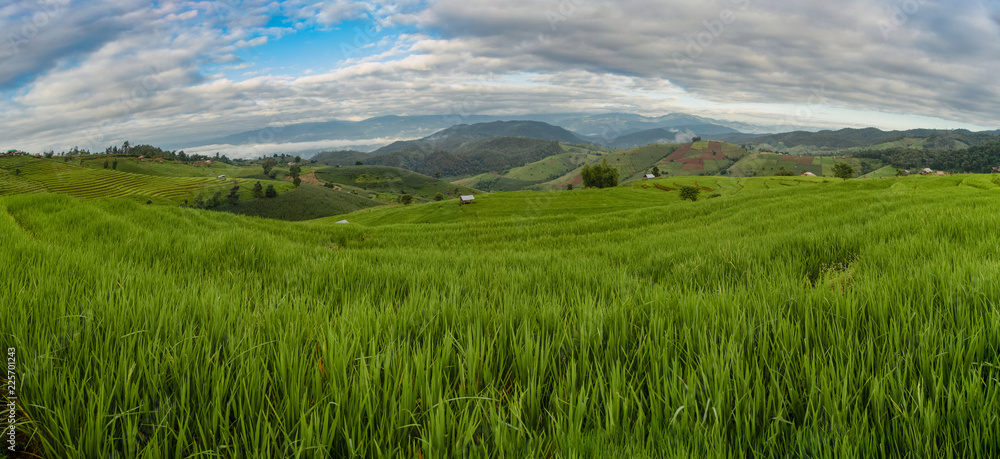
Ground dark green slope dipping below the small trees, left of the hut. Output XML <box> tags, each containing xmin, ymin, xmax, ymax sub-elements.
<box><xmin>217</xmin><ymin>183</ymin><xmax>382</xmax><ymax>221</ymax></box>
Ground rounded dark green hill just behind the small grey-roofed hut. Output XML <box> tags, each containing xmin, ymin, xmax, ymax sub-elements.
<box><xmin>316</xmin><ymin>166</ymin><xmax>477</xmax><ymax>201</ymax></box>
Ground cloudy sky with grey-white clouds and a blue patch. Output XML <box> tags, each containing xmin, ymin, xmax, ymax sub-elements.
<box><xmin>0</xmin><ymin>0</ymin><xmax>1000</xmax><ymax>155</ymax></box>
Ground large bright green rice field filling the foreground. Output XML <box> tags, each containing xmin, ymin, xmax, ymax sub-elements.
<box><xmin>0</xmin><ymin>176</ymin><xmax>1000</xmax><ymax>458</ymax></box>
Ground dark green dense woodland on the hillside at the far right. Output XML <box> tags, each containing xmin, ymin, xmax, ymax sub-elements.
<box><xmin>854</xmin><ymin>141</ymin><xmax>1000</xmax><ymax>174</ymax></box>
